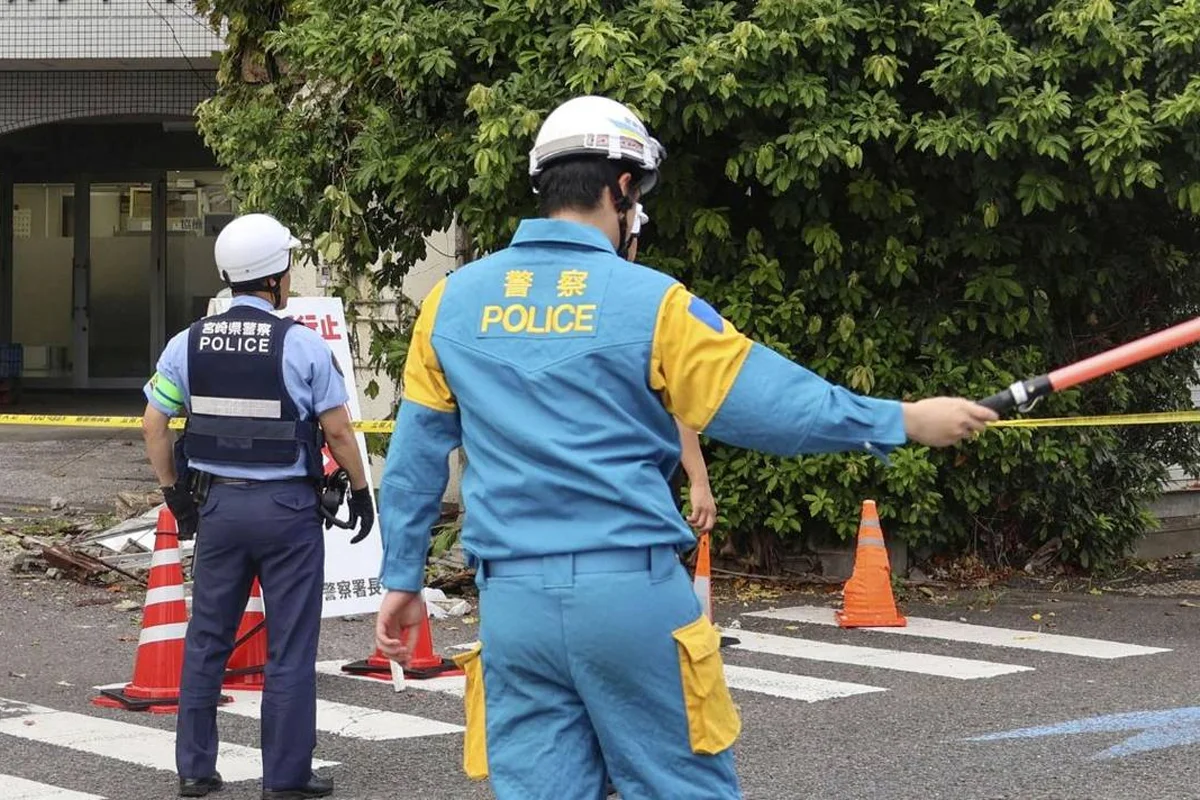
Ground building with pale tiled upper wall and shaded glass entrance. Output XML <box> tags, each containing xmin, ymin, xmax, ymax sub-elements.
<box><xmin>0</xmin><ymin>0</ymin><xmax>454</xmax><ymax>416</ymax></box>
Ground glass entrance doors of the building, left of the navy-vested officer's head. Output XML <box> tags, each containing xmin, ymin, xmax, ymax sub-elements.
<box><xmin>8</xmin><ymin>170</ymin><xmax>236</xmax><ymax>389</ymax></box>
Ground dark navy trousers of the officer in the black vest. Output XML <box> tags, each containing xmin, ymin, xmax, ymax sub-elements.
<box><xmin>175</xmin><ymin>481</ymin><xmax>325</xmax><ymax>789</ymax></box>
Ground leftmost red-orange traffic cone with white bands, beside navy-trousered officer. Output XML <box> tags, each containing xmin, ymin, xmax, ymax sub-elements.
<box><xmin>91</xmin><ymin>509</ymin><xmax>230</xmax><ymax>714</ymax></box>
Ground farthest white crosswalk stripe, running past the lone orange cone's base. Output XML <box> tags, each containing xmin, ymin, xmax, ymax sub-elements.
<box><xmin>745</xmin><ymin>606</ymin><xmax>1170</xmax><ymax>658</ymax></box>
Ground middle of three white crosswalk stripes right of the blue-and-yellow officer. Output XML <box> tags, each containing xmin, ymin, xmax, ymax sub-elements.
<box><xmin>731</xmin><ymin>630</ymin><xmax>1033</xmax><ymax>680</ymax></box>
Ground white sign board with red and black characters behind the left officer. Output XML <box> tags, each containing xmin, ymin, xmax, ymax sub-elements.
<box><xmin>202</xmin><ymin>297</ymin><xmax>384</xmax><ymax>618</ymax></box>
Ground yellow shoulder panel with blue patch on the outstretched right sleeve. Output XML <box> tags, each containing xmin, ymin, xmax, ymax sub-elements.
<box><xmin>650</xmin><ymin>283</ymin><xmax>751</xmax><ymax>432</ymax></box>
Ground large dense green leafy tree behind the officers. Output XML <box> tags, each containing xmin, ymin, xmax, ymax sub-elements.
<box><xmin>192</xmin><ymin>0</ymin><xmax>1200</xmax><ymax>575</ymax></box>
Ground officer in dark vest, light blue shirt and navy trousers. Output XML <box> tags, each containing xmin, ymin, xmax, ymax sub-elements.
<box><xmin>143</xmin><ymin>213</ymin><xmax>374</xmax><ymax>800</ymax></box>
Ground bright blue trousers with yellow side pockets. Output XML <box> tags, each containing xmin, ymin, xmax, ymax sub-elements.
<box><xmin>460</xmin><ymin>547</ymin><xmax>742</xmax><ymax>800</ymax></box>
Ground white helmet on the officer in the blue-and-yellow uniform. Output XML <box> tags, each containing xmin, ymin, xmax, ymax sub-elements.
<box><xmin>529</xmin><ymin>95</ymin><xmax>667</xmax><ymax>194</ymax></box>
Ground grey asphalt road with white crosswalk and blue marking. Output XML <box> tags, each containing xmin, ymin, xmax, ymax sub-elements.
<box><xmin>0</xmin><ymin>563</ymin><xmax>1200</xmax><ymax>800</ymax></box>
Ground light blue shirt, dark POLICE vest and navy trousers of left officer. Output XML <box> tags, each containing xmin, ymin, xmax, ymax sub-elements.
<box><xmin>144</xmin><ymin>295</ymin><xmax>348</xmax><ymax>790</ymax></box>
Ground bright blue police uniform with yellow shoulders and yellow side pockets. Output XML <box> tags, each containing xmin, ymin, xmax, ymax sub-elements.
<box><xmin>379</xmin><ymin>219</ymin><xmax>905</xmax><ymax>800</ymax></box>
